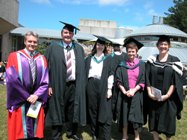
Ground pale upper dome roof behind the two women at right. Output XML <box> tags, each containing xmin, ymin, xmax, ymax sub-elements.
<box><xmin>128</xmin><ymin>24</ymin><xmax>187</xmax><ymax>38</ymax></box>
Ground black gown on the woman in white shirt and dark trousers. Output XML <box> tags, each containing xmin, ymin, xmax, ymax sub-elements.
<box><xmin>85</xmin><ymin>56</ymin><xmax>113</xmax><ymax>124</ymax></box>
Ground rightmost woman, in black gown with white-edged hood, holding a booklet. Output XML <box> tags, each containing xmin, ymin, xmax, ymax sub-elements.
<box><xmin>146</xmin><ymin>36</ymin><xmax>183</xmax><ymax>140</ymax></box>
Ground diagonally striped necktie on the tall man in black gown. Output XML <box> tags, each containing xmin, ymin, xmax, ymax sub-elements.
<box><xmin>66</xmin><ymin>45</ymin><xmax>72</xmax><ymax>79</ymax></box>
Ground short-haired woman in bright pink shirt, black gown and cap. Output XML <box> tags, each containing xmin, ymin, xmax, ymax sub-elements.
<box><xmin>115</xmin><ymin>38</ymin><xmax>145</xmax><ymax>140</ymax></box>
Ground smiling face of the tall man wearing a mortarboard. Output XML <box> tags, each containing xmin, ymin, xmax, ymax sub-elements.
<box><xmin>61</xmin><ymin>29</ymin><xmax>74</xmax><ymax>44</ymax></box>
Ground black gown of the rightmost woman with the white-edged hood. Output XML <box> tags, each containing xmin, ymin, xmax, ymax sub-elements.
<box><xmin>146</xmin><ymin>55</ymin><xmax>183</xmax><ymax>136</ymax></box>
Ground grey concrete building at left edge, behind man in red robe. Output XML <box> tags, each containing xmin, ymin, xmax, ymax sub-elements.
<box><xmin>0</xmin><ymin>0</ymin><xmax>19</xmax><ymax>60</ymax></box>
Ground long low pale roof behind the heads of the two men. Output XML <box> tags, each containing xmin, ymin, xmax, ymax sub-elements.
<box><xmin>10</xmin><ymin>27</ymin><xmax>95</xmax><ymax>40</ymax></box>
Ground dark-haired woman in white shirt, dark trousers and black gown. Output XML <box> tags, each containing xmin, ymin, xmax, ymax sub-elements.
<box><xmin>85</xmin><ymin>37</ymin><xmax>114</xmax><ymax>140</ymax></box>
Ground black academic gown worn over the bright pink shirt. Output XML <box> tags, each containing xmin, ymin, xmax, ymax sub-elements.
<box><xmin>115</xmin><ymin>60</ymin><xmax>145</xmax><ymax>131</ymax></box>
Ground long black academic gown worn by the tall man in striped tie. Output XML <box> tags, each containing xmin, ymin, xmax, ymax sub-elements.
<box><xmin>45</xmin><ymin>42</ymin><xmax>86</xmax><ymax>126</ymax></box>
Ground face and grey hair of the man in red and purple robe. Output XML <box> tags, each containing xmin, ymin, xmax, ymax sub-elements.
<box><xmin>24</xmin><ymin>35</ymin><xmax>38</xmax><ymax>52</ymax></box>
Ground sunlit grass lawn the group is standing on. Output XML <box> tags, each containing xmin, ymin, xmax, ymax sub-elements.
<box><xmin>0</xmin><ymin>85</ymin><xmax>187</xmax><ymax>140</ymax></box>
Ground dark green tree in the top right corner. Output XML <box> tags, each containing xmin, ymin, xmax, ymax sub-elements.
<box><xmin>164</xmin><ymin>0</ymin><xmax>187</xmax><ymax>33</ymax></box>
